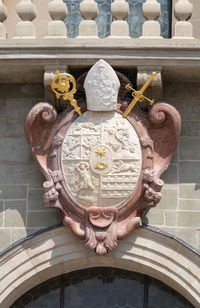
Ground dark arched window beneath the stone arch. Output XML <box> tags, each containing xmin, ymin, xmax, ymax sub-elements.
<box><xmin>11</xmin><ymin>267</ymin><xmax>194</xmax><ymax>308</ymax></box>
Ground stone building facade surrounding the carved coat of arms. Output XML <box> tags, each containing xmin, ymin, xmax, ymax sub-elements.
<box><xmin>0</xmin><ymin>0</ymin><xmax>200</xmax><ymax>308</ymax></box>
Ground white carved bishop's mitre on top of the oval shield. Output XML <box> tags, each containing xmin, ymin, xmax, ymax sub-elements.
<box><xmin>83</xmin><ymin>59</ymin><xmax>120</xmax><ymax>111</ymax></box>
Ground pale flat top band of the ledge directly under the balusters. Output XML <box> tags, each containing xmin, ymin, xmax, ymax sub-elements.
<box><xmin>1</xmin><ymin>37</ymin><xmax>200</xmax><ymax>51</ymax></box>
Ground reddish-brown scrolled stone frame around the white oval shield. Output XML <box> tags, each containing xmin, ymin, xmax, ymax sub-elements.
<box><xmin>25</xmin><ymin>64</ymin><xmax>181</xmax><ymax>255</ymax></box>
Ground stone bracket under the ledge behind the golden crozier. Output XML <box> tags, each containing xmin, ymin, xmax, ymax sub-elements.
<box><xmin>43</xmin><ymin>65</ymin><xmax>69</xmax><ymax>107</ymax></box>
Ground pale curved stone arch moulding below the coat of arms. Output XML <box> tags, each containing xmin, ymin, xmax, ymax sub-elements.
<box><xmin>0</xmin><ymin>226</ymin><xmax>200</xmax><ymax>308</ymax></box>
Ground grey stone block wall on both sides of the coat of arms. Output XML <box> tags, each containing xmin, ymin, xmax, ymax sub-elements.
<box><xmin>0</xmin><ymin>80</ymin><xmax>200</xmax><ymax>253</ymax></box>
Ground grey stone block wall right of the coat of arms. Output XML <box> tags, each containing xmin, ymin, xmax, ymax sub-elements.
<box><xmin>147</xmin><ymin>80</ymin><xmax>200</xmax><ymax>249</ymax></box>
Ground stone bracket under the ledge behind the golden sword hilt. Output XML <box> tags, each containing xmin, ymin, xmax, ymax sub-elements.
<box><xmin>137</xmin><ymin>66</ymin><xmax>163</xmax><ymax>106</ymax></box>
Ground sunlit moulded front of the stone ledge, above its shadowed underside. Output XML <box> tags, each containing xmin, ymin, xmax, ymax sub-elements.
<box><xmin>0</xmin><ymin>38</ymin><xmax>200</xmax><ymax>66</ymax></box>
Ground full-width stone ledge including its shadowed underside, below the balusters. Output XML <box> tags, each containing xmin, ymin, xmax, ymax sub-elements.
<box><xmin>0</xmin><ymin>38</ymin><xmax>200</xmax><ymax>84</ymax></box>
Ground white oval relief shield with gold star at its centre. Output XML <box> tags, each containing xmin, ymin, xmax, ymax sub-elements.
<box><xmin>61</xmin><ymin>111</ymin><xmax>142</xmax><ymax>206</ymax></box>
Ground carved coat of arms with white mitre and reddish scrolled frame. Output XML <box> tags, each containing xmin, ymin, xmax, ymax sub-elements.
<box><xmin>25</xmin><ymin>60</ymin><xmax>181</xmax><ymax>255</ymax></box>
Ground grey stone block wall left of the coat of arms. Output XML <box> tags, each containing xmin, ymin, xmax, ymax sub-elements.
<box><xmin>0</xmin><ymin>85</ymin><xmax>62</xmax><ymax>250</ymax></box>
